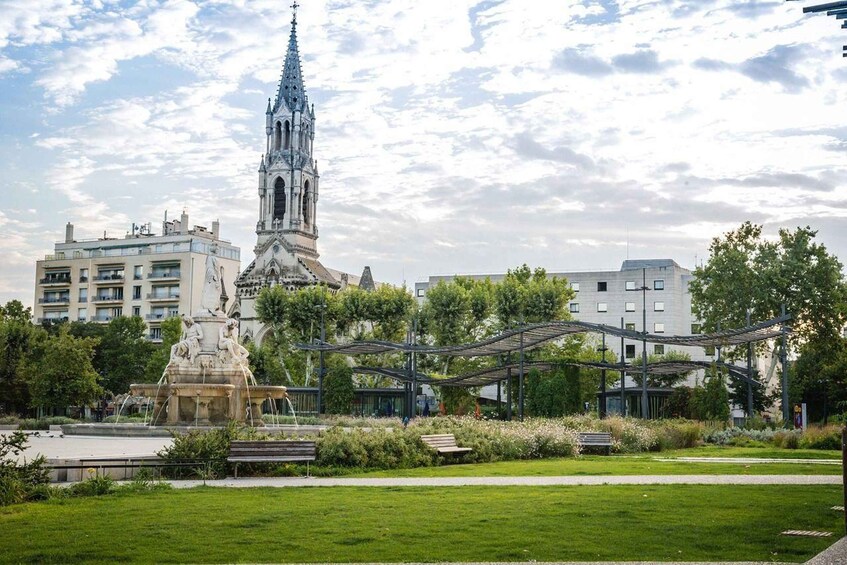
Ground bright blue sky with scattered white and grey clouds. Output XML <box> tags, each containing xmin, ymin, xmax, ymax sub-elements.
<box><xmin>0</xmin><ymin>0</ymin><xmax>847</xmax><ymax>305</ymax></box>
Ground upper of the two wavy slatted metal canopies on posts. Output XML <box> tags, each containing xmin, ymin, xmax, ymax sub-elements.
<box><xmin>296</xmin><ymin>315</ymin><xmax>791</xmax><ymax>357</ymax></box>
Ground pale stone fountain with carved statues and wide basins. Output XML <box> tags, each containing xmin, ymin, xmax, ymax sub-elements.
<box><xmin>130</xmin><ymin>254</ymin><xmax>286</xmax><ymax>426</ymax></box>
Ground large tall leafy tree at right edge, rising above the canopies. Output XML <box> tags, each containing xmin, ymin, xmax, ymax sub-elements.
<box><xmin>689</xmin><ymin>222</ymin><xmax>847</xmax><ymax>420</ymax></box>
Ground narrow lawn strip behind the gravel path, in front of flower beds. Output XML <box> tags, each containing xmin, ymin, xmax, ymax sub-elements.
<box><xmin>352</xmin><ymin>449</ymin><xmax>841</xmax><ymax>477</ymax></box>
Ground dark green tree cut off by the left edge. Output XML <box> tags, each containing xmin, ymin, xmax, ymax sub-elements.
<box><xmin>0</xmin><ymin>300</ymin><xmax>41</xmax><ymax>414</ymax></box>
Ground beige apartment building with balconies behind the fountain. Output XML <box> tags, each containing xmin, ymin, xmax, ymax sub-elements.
<box><xmin>34</xmin><ymin>212</ymin><xmax>241</xmax><ymax>341</ymax></box>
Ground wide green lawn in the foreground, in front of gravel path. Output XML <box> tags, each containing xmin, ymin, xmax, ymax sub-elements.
<box><xmin>0</xmin><ymin>485</ymin><xmax>843</xmax><ymax>563</ymax></box>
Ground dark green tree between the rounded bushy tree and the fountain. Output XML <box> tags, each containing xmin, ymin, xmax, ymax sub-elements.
<box><xmin>95</xmin><ymin>316</ymin><xmax>155</xmax><ymax>394</ymax></box>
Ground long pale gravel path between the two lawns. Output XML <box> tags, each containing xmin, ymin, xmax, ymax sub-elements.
<box><xmin>171</xmin><ymin>475</ymin><xmax>841</xmax><ymax>488</ymax></box>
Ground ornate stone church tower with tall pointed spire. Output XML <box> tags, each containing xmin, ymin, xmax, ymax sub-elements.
<box><xmin>229</xmin><ymin>2</ymin><xmax>348</xmax><ymax>341</ymax></box>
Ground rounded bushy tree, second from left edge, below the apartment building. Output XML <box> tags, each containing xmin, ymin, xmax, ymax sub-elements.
<box><xmin>23</xmin><ymin>327</ymin><xmax>103</xmax><ymax>412</ymax></box>
